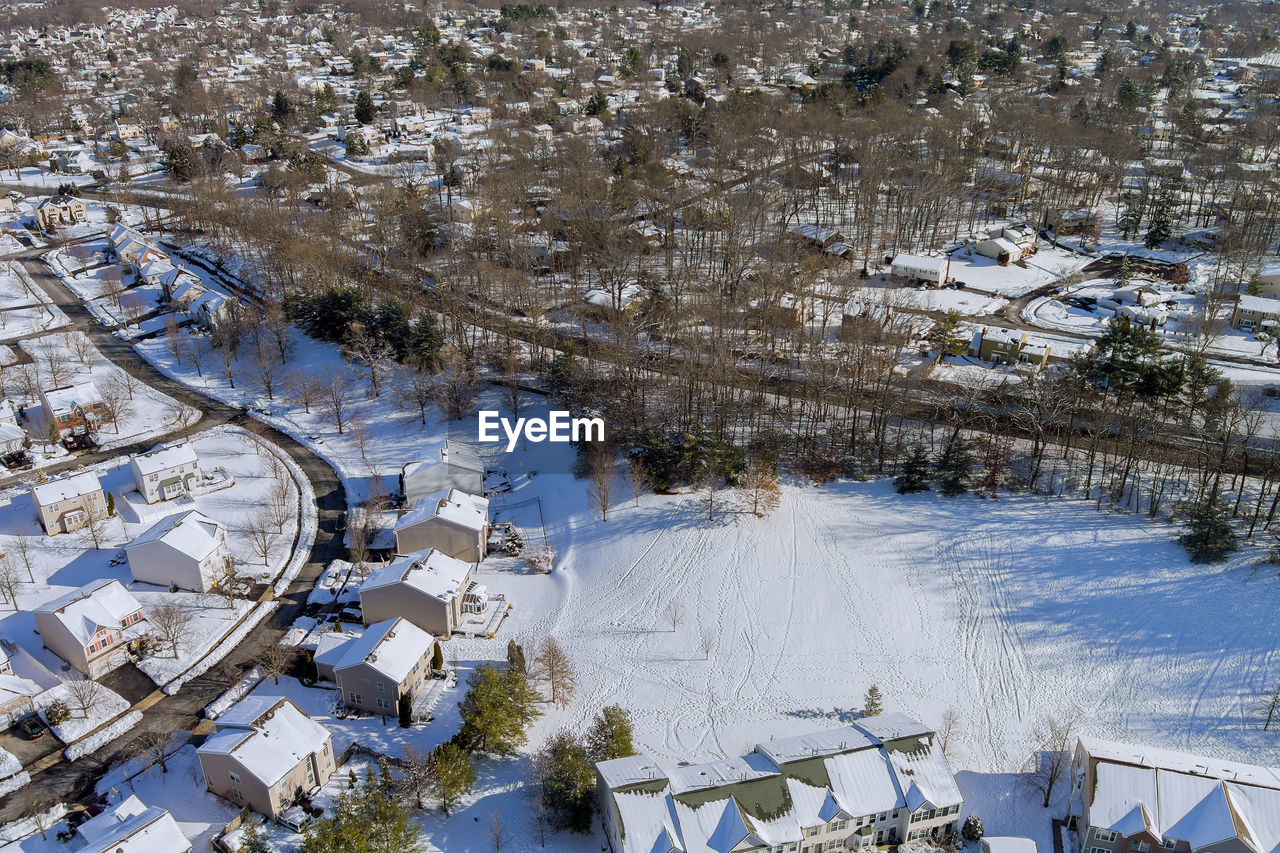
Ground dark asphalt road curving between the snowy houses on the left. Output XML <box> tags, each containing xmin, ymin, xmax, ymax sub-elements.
<box><xmin>0</xmin><ymin>250</ymin><xmax>347</xmax><ymax>822</ymax></box>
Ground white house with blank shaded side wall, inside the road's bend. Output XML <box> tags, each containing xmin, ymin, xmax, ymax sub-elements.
<box><xmin>124</xmin><ymin>510</ymin><xmax>230</xmax><ymax>592</ymax></box>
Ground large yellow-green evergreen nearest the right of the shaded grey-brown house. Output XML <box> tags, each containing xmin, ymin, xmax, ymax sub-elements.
<box><xmin>458</xmin><ymin>663</ymin><xmax>541</xmax><ymax>754</ymax></box>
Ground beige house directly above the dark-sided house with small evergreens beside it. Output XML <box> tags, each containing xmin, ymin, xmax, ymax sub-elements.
<box><xmin>360</xmin><ymin>551</ymin><xmax>484</xmax><ymax>637</ymax></box>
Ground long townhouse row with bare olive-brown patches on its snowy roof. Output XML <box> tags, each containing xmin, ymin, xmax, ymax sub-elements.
<box><xmin>596</xmin><ymin>715</ymin><xmax>964</xmax><ymax>853</ymax></box>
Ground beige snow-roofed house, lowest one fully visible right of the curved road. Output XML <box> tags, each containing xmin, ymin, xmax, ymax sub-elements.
<box><xmin>196</xmin><ymin>695</ymin><xmax>335</xmax><ymax>817</ymax></box>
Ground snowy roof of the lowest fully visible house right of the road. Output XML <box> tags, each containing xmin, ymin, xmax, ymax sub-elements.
<box><xmin>197</xmin><ymin>695</ymin><xmax>329</xmax><ymax>786</ymax></box>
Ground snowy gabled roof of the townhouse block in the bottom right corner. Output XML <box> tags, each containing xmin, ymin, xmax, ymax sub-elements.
<box><xmin>1080</xmin><ymin>738</ymin><xmax>1280</xmax><ymax>853</ymax></box>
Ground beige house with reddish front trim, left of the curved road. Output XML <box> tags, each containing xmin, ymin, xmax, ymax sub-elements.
<box><xmin>36</xmin><ymin>578</ymin><xmax>142</xmax><ymax>679</ymax></box>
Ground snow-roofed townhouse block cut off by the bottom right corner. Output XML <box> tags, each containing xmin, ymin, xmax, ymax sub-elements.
<box><xmin>1068</xmin><ymin>738</ymin><xmax>1280</xmax><ymax>853</ymax></box>
